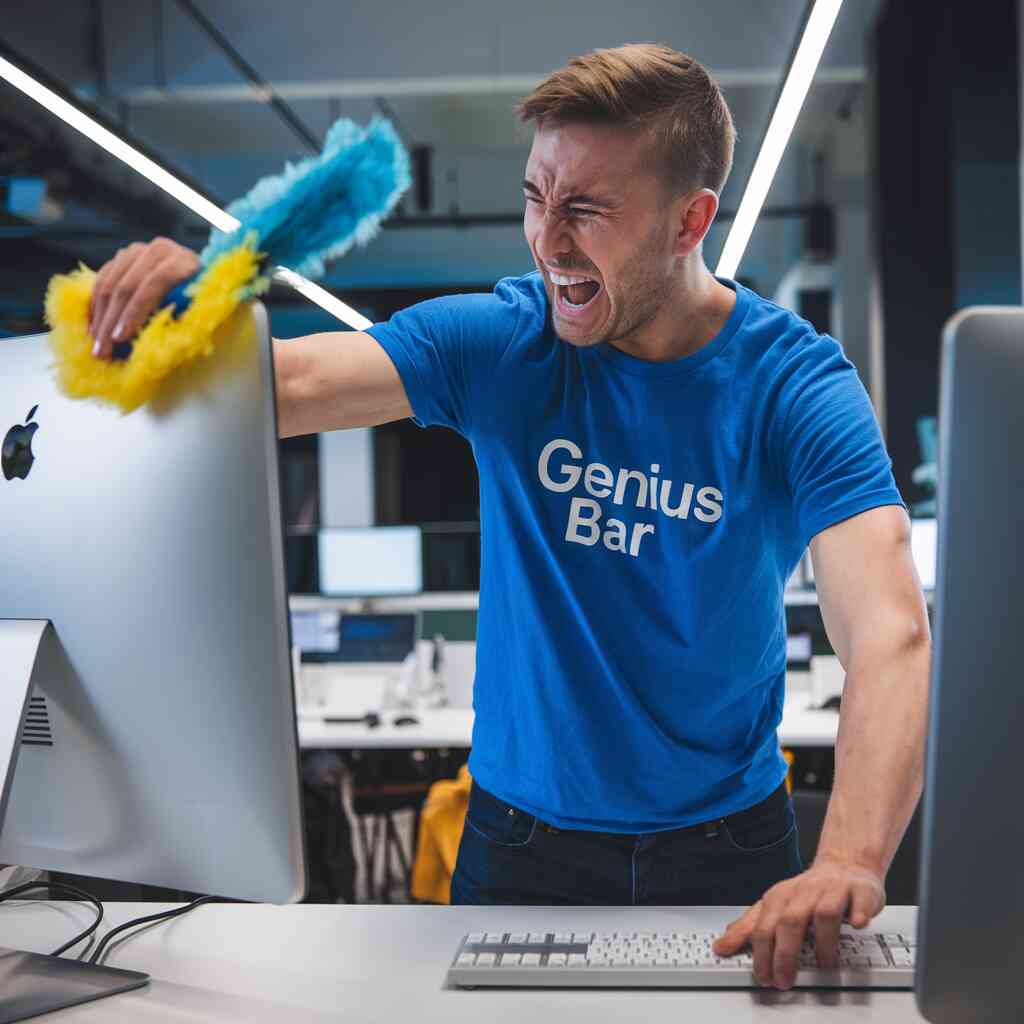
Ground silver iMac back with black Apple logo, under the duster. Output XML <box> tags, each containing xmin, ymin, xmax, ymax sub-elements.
<box><xmin>0</xmin><ymin>302</ymin><xmax>305</xmax><ymax>903</ymax></box>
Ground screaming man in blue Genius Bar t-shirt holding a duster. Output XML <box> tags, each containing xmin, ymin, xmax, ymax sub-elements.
<box><xmin>92</xmin><ymin>45</ymin><xmax>929</xmax><ymax>987</ymax></box>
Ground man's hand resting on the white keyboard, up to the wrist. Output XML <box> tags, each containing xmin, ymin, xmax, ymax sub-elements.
<box><xmin>714</xmin><ymin>860</ymin><xmax>886</xmax><ymax>988</ymax></box>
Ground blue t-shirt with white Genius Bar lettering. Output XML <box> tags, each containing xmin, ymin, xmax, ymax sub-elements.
<box><xmin>367</xmin><ymin>272</ymin><xmax>903</xmax><ymax>833</ymax></box>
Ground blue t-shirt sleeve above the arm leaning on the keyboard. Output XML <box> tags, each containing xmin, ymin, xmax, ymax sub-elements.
<box><xmin>778</xmin><ymin>335</ymin><xmax>906</xmax><ymax>547</ymax></box>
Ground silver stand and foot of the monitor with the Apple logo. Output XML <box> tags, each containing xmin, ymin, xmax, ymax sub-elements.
<box><xmin>0</xmin><ymin>618</ymin><xmax>150</xmax><ymax>1024</ymax></box>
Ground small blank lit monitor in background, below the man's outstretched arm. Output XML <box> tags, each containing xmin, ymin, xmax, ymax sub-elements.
<box><xmin>317</xmin><ymin>526</ymin><xmax>423</xmax><ymax>597</ymax></box>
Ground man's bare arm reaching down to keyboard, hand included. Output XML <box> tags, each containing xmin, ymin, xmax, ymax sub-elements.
<box><xmin>716</xmin><ymin>506</ymin><xmax>931</xmax><ymax>988</ymax></box>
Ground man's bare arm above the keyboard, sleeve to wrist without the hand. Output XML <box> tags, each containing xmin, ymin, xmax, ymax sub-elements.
<box><xmin>811</xmin><ymin>506</ymin><xmax>931</xmax><ymax>888</ymax></box>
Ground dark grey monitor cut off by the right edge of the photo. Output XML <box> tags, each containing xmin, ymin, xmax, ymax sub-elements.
<box><xmin>915</xmin><ymin>306</ymin><xmax>1024</xmax><ymax>1024</ymax></box>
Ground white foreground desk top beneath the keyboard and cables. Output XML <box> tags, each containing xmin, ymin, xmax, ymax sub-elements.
<box><xmin>0</xmin><ymin>903</ymin><xmax>922</xmax><ymax>1024</ymax></box>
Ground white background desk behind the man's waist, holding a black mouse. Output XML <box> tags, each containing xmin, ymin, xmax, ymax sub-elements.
<box><xmin>299</xmin><ymin>692</ymin><xmax>839</xmax><ymax>750</ymax></box>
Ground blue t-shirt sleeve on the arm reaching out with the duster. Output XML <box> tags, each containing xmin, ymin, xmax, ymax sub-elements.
<box><xmin>366</xmin><ymin>279</ymin><xmax>519</xmax><ymax>437</ymax></box>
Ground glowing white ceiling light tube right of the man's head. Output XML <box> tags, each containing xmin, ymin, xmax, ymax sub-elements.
<box><xmin>715</xmin><ymin>0</ymin><xmax>843</xmax><ymax>278</ymax></box>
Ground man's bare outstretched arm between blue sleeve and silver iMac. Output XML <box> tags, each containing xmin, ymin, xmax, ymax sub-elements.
<box><xmin>273</xmin><ymin>331</ymin><xmax>413</xmax><ymax>437</ymax></box>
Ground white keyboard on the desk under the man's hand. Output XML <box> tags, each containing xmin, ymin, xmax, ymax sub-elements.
<box><xmin>447</xmin><ymin>926</ymin><xmax>916</xmax><ymax>988</ymax></box>
